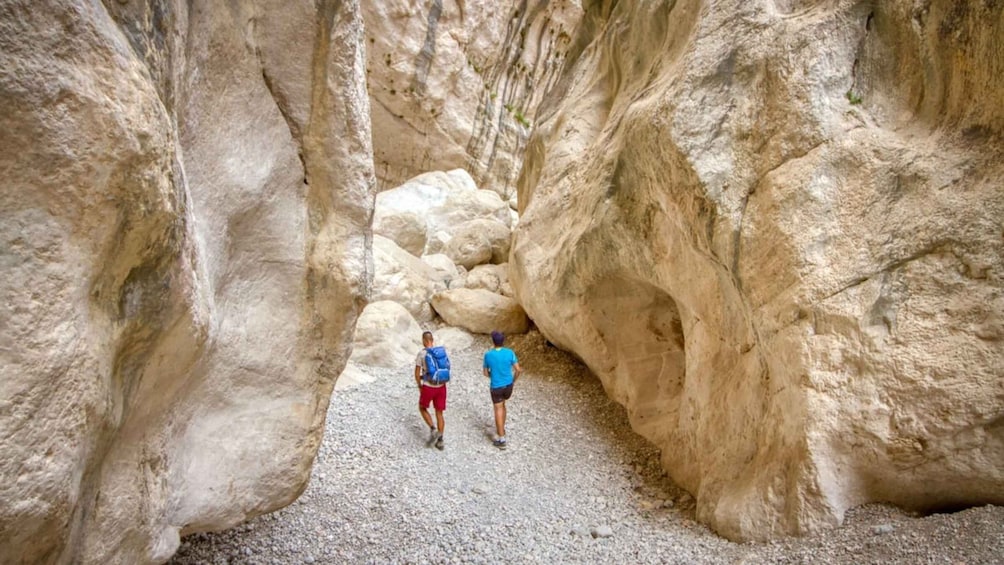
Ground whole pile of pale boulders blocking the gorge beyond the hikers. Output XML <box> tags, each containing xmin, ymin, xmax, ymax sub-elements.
<box><xmin>346</xmin><ymin>169</ymin><xmax>529</xmax><ymax>377</ymax></box>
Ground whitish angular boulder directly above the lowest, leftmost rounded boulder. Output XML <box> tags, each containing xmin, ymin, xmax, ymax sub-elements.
<box><xmin>369</xmin><ymin>235</ymin><xmax>446</xmax><ymax>322</ymax></box>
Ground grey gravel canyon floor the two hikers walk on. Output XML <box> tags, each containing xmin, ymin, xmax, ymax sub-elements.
<box><xmin>172</xmin><ymin>333</ymin><xmax>1004</xmax><ymax>565</ymax></box>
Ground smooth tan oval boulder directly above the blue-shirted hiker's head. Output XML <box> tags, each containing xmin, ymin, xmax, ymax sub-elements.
<box><xmin>432</xmin><ymin>288</ymin><xmax>529</xmax><ymax>333</ymax></box>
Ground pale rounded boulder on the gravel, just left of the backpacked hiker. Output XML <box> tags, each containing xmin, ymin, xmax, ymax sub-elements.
<box><xmin>349</xmin><ymin>300</ymin><xmax>422</xmax><ymax>368</ymax></box>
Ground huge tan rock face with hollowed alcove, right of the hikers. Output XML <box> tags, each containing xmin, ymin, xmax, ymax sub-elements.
<box><xmin>510</xmin><ymin>0</ymin><xmax>1004</xmax><ymax>539</ymax></box>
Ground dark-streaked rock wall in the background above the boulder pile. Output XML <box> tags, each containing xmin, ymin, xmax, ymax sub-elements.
<box><xmin>362</xmin><ymin>0</ymin><xmax>582</xmax><ymax>198</ymax></box>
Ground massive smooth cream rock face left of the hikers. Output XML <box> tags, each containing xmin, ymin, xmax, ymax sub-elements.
<box><xmin>0</xmin><ymin>0</ymin><xmax>373</xmax><ymax>563</ymax></box>
